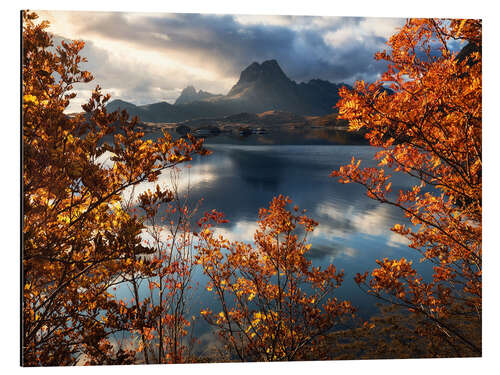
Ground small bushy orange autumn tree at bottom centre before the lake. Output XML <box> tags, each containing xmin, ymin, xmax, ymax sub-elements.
<box><xmin>198</xmin><ymin>195</ymin><xmax>354</xmax><ymax>361</ymax></box>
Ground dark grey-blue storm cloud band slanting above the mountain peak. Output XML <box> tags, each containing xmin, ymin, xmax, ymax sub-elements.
<box><xmin>80</xmin><ymin>13</ymin><xmax>398</xmax><ymax>82</ymax></box>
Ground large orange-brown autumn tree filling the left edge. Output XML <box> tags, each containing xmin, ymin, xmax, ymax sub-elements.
<box><xmin>22</xmin><ymin>12</ymin><xmax>206</xmax><ymax>366</ymax></box>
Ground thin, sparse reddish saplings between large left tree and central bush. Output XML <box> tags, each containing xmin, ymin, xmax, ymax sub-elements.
<box><xmin>121</xmin><ymin>168</ymin><xmax>199</xmax><ymax>364</ymax></box>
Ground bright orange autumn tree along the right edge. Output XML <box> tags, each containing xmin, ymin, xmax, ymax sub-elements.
<box><xmin>332</xmin><ymin>19</ymin><xmax>482</xmax><ymax>355</ymax></box>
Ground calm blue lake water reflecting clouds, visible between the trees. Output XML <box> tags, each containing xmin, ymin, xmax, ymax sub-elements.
<box><xmin>109</xmin><ymin>132</ymin><xmax>429</xmax><ymax>352</ymax></box>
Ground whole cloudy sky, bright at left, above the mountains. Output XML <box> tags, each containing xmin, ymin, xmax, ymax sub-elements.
<box><xmin>37</xmin><ymin>11</ymin><xmax>405</xmax><ymax>112</ymax></box>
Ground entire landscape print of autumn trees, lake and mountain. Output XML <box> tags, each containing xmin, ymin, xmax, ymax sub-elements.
<box><xmin>20</xmin><ymin>9</ymin><xmax>483</xmax><ymax>370</ymax></box>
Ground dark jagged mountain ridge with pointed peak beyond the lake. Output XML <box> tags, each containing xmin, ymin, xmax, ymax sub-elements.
<box><xmin>107</xmin><ymin>60</ymin><xmax>348</xmax><ymax>122</ymax></box>
